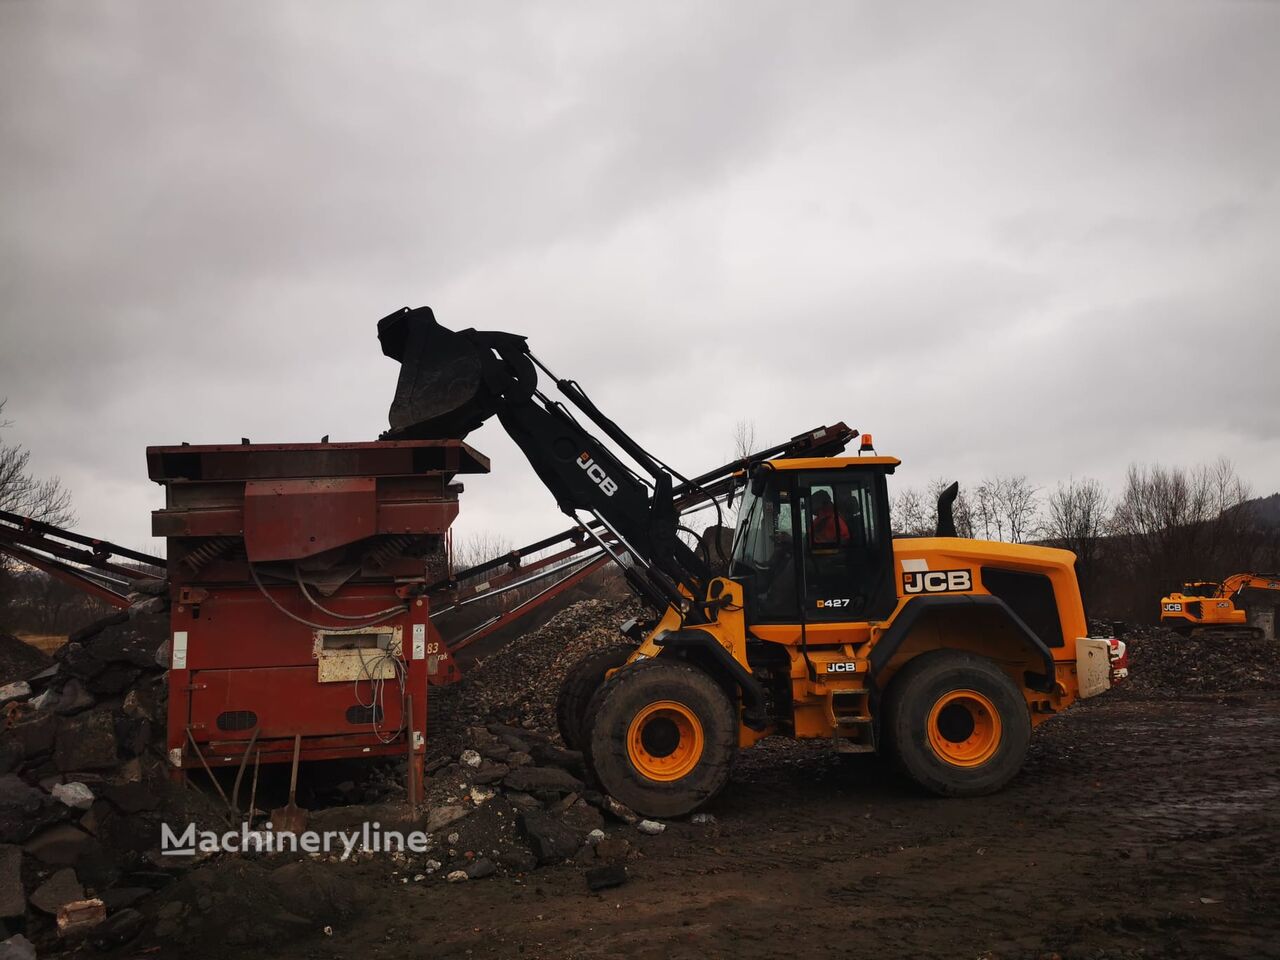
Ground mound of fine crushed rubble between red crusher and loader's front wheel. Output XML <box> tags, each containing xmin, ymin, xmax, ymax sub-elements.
<box><xmin>454</xmin><ymin>596</ymin><xmax>652</xmax><ymax>730</ymax></box>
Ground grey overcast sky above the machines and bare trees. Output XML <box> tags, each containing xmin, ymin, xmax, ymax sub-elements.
<box><xmin>0</xmin><ymin>0</ymin><xmax>1280</xmax><ymax>547</ymax></box>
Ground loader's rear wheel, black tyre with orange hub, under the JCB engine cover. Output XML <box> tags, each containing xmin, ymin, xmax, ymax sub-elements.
<box><xmin>882</xmin><ymin>650</ymin><xmax>1032</xmax><ymax>796</ymax></box>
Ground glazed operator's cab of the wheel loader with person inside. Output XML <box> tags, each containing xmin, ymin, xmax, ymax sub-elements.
<box><xmin>730</xmin><ymin>457</ymin><xmax>897</xmax><ymax>623</ymax></box>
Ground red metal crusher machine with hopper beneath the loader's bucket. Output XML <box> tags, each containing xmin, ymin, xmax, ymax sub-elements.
<box><xmin>147</xmin><ymin>440</ymin><xmax>489</xmax><ymax>800</ymax></box>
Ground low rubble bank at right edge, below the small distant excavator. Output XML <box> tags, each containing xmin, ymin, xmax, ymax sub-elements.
<box><xmin>1116</xmin><ymin>625</ymin><xmax>1280</xmax><ymax>694</ymax></box>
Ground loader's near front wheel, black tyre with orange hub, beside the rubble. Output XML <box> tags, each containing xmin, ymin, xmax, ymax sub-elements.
<box><xmin>582</xmin><ymin>659</ymin><xmax>739</xmax><ymax>817</ymax></box>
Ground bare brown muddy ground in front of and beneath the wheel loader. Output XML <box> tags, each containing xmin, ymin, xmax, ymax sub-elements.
<box><xmin>255</xmin><ymin>691</ymin><xmax>1280</xmax><ymax>960</ymax></box>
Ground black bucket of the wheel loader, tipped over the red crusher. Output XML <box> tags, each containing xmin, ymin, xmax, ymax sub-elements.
<box><xmin>378</xmin><ymin>307</ymin><xmax>497</xmax><ymax>440</ymax></box>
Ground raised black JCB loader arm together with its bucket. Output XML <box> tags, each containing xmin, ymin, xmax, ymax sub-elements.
<box><xmin>378</xmin><ymin>307</ymin><xmax>712</xmax><ymax>612</ymax></box>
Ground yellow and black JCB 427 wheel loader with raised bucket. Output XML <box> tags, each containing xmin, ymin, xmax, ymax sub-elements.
<box><xmin>379</xmin><ymin>307</ymin><xmax>1124</xmax><ymax>817</ymax></box>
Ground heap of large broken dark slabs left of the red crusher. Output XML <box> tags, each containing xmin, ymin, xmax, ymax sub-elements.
<box><xmin>0</xmin><ymin>598</ymin><xmax>224</xmax><ymax>956</ymax></box>
